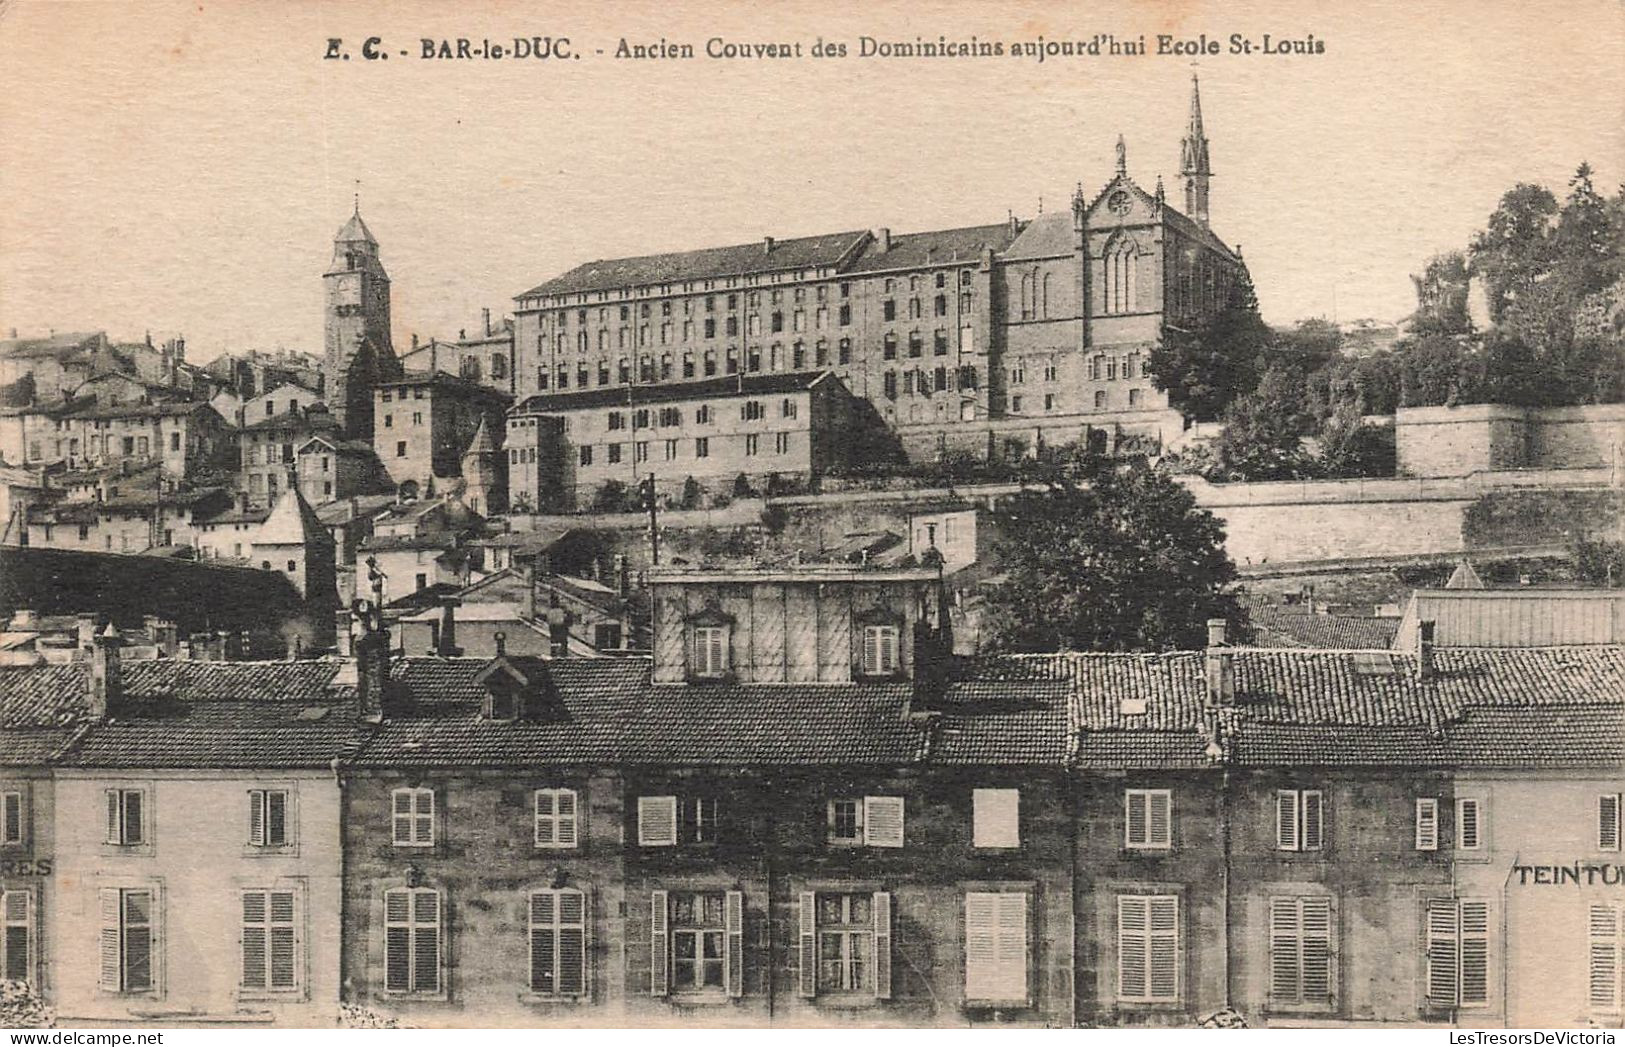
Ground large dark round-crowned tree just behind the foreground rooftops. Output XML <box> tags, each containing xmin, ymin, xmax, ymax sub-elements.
<box><xmin>986</xmin><ymin>465</ymin><xmax>1240</xmax><ymax>652</ymax></box>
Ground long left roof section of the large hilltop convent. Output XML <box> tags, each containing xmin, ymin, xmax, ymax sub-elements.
<box><xmin>518</xmin><ymin>231</ymin><xmax>868</xmax><ymax>298</ymax></box>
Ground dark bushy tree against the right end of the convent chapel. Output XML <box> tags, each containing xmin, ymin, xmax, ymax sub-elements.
<box><xmin>1146</xmin><ymin>267</ymin><xmax>1271</xmax><ymax>421</ymax></box>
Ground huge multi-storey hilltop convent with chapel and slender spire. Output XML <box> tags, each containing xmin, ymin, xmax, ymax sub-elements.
<box><xmin>514</xmin><ymin>80</ymin><xmax>1243</xmax><ymax>470</ymax></box>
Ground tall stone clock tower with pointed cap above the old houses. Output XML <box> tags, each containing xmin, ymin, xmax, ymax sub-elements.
<box><xmin>322</xmin><ymin>206</ymin><xmax>400</xmax><ymax>441</ymax></box>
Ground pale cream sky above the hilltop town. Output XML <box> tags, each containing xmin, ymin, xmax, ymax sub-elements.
<box><xmin>0</xmin><ymin>0</ymin><xmax>1625</xmax><ymax>361</ymax></box>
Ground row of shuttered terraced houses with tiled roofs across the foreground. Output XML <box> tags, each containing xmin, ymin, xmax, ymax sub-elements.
<box><xmin>0</xmin><ymin>582</ymin><xmax>1625</xmax><ymax>1026</ymax></box>
